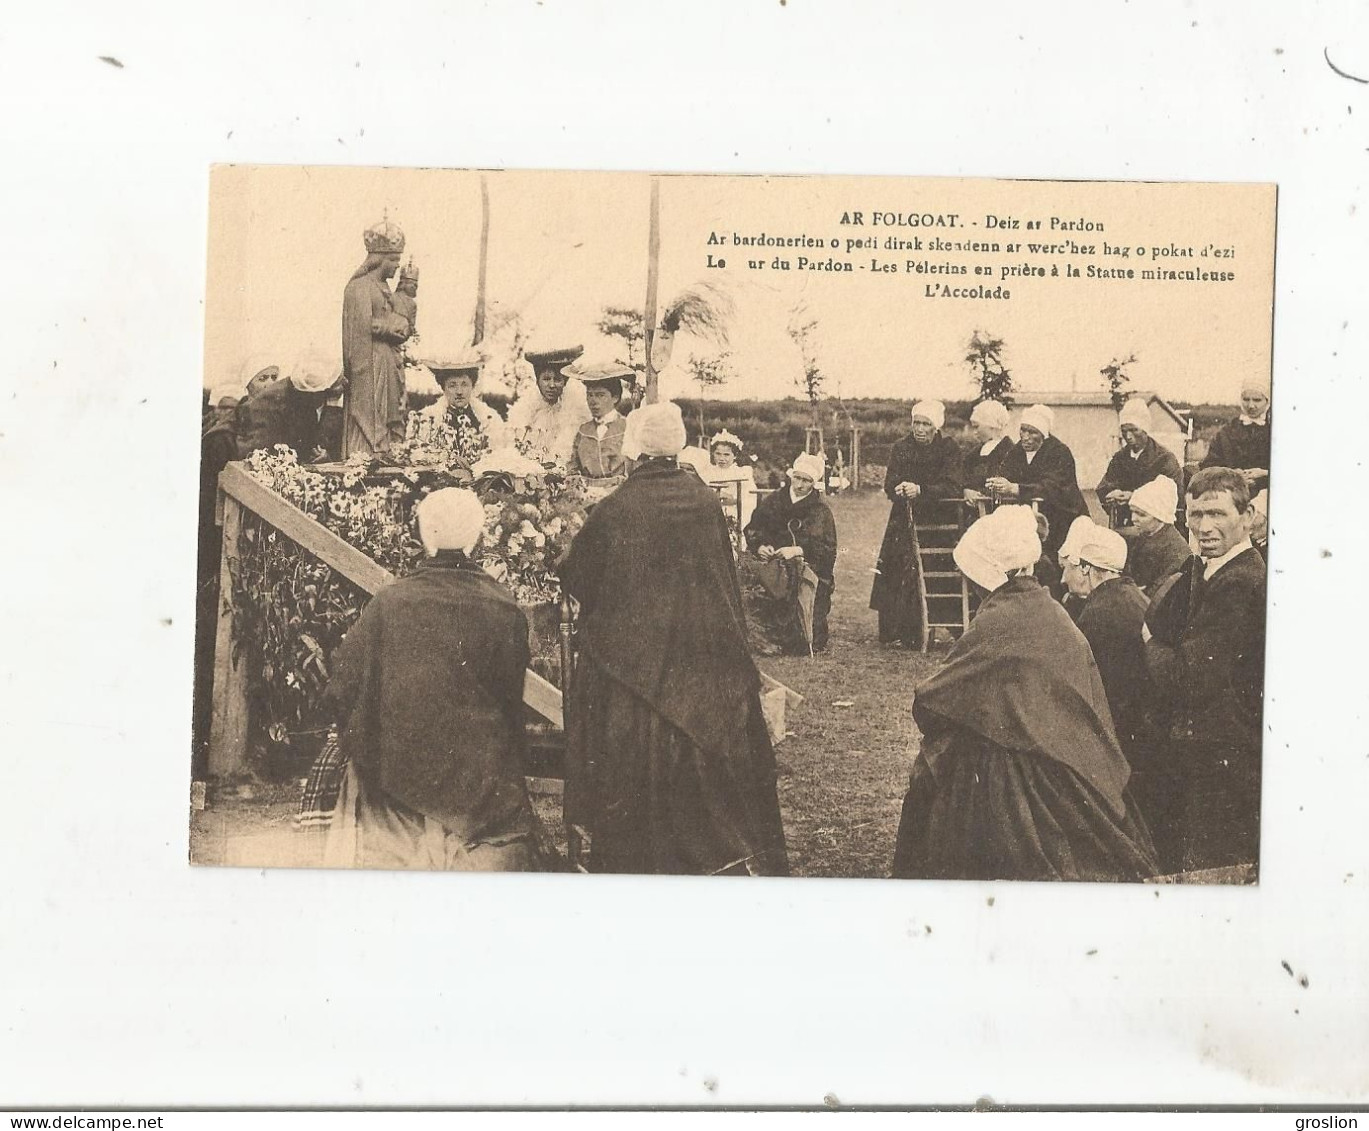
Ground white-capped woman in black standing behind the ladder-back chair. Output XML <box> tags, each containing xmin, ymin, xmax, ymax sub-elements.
<box><xmin>869</xmin><ymin>401</ymin><xmax>964</xmax><ymax>648</ymax></box>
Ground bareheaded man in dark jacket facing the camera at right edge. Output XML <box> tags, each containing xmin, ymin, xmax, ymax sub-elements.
<box><xmin>1146</xmin><ymin>467</ymin><xmax>1265</xmax><ymax>871</ymax></box>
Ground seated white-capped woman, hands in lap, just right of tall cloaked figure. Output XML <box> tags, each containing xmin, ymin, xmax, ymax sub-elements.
<box><xmin>743</xmin><ymin>455</ymin><xmax>836</xmax><ymax>652</ymax></box>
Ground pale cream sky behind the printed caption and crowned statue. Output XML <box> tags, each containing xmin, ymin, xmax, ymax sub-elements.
<box><xmin>204</xmin><ymin>166</ymin><xmax>1275</xmax><ymax>403</ymax></box>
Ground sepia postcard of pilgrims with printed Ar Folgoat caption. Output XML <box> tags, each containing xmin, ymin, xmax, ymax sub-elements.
<box><xmin>189</xmin><ymin>166</ymin><xmax>1277</xmax><ymax>885</ymax></box>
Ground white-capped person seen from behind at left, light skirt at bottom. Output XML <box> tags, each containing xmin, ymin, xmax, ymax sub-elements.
<box><xmin>327</xmin><ymin>487</ymin><xmax>543</xmax><ymax>872</ymax></box>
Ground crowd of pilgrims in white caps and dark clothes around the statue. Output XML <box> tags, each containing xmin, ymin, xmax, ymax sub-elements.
<box><xmin>201</xmin><ymin>335</ymin><xmax>1269</xmax><ymax>880</ymax></box>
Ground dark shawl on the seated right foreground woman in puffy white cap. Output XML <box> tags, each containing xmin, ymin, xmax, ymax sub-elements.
<box><xmin>913</xmin><ymin>576</ymin><xmax>1131</xmax><ymax>817</ymax></box>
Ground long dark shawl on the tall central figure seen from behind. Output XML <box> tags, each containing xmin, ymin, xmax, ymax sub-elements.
<box><xmin>560</xmin><ymin>460</ymin><xmax>760</xmax><ymax>752</ymax></box>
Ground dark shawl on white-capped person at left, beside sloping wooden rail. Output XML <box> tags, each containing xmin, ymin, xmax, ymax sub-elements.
<box><xmin>327</xmin><ymin>550</ymin><xmax>531</xmax><ymax>843</ymax></box>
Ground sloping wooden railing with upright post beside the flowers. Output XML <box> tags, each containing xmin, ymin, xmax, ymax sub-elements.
<box><xmin>209</xmin><ymin>463</ymin><xmax>564</xmax><ymax>776</ymax></box>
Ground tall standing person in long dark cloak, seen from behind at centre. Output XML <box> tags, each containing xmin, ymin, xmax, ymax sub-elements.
<box><xmin>560</xmin><ymin>404</ymin><xmax>789</xmax><ymax>875</ymax></box>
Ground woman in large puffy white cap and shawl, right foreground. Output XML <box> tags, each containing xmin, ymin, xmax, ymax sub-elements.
<box><xmin>894</xmin><ymin>507</ymin><xmax>1158</xmax><ymax>880</ymax></box>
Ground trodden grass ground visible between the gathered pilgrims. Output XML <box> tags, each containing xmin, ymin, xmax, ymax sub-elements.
<box><xmin>190</xmin><ymin>493</ymin><xmax>935</xmax><ymax>876</ymax></box>
